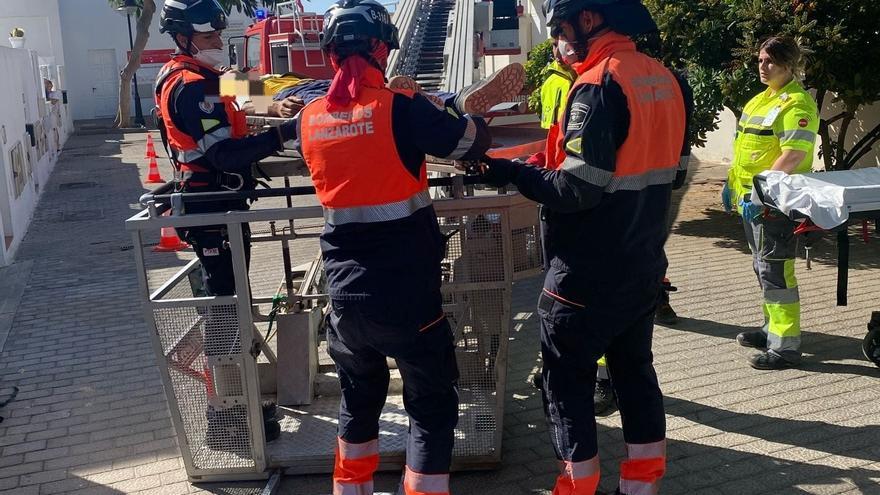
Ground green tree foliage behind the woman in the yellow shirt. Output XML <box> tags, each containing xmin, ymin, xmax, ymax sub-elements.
<box><xmin>644</xmin><ymin>0</ymin><xmax>880</xmax><ymax>170</ymax></box>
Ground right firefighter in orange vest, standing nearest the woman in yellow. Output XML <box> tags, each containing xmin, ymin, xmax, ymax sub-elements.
<box><xmin>483</xmin><ymin>0</ymin><xmax>687</xmax><ymax>495</ymax></box>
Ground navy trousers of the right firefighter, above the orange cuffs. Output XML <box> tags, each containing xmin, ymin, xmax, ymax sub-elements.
<box><xmin>538</xmin><ymin>263</ymin><xmax>666</xmax><ymax>462</ymax></box>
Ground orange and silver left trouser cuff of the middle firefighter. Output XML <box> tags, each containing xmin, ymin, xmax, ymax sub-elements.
<box><xmin>333</xmin><ymin>438</ymin><xmax>379</xmax><ymax>495</ymax></box>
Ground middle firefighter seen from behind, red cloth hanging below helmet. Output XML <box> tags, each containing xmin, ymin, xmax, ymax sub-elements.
<box><xmin>298</xmin><ymin>0</ymin><xmax>491</xmax><ymax>495</ymax></box>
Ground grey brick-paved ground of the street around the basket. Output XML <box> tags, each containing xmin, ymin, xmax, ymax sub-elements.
<box><xmin>0</xmin><ymin>134</ymin><xmax>880</xmax><ymax>495</ymax></box>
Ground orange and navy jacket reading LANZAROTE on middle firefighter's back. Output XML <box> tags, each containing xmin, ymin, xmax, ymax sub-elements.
<box><xmin>297</xmin><ymin>67</ymin><xmax>491</xmax><ymax>318</ymax></box>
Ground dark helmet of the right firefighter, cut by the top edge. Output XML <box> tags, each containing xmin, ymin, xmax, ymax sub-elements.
<box><xmin>541</xmin><ymin>0</ymin><xmax>657</xmax><ymax>36</ymax></box>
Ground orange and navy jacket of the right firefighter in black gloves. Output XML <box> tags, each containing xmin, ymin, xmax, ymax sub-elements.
<box><xmin>512</xmin><ymin>33</ymin><xmax>687</xmax><ymax>288</ymax></box>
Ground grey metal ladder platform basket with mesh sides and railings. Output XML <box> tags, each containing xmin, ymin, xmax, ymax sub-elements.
<box><xmin>126</xmin><ymin>167</ymin><xmax>541</xmax><ymax>482</ymax></box>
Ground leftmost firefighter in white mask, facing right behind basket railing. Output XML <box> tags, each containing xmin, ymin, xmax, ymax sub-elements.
<box><xmin>156</xmin><ymin>0</ymin><xmax>296</xmax><ymax>453</ymax></box>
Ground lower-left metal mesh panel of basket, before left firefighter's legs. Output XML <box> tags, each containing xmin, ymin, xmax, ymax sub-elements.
<box><xmin>153</xmin><ymin>305</ymin><xmax>255</xmax><ymax>471</ymax></box>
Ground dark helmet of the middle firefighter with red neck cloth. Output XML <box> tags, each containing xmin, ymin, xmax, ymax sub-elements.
<box><xmin>321</xmin><ymin>0</ymin><xmax>400</xmax><ymax>51</ymax></box>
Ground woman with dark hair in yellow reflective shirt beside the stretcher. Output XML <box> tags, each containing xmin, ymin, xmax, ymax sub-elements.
<box><xmin>722</xmin><ymin>36</ymin><xmax>819</xmax><ymax>370</ymax></box>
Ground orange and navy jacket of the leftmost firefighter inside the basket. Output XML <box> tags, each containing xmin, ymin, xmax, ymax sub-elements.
<box><xmin>155</xmin><ymin>53</ymin><xmax>281</xmax><ymax>213</ymax></box>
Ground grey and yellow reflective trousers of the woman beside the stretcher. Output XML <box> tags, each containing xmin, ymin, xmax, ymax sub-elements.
<box><xmin>743</xmin><ymin>214</ymin><xmax>801</xmax><ymax>352</ymax></box>
